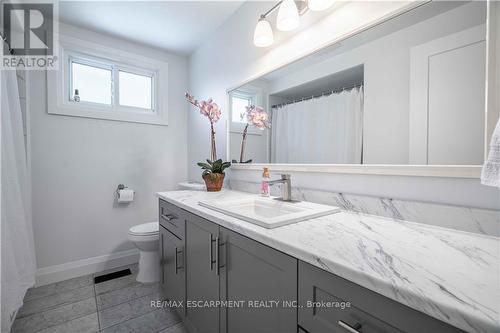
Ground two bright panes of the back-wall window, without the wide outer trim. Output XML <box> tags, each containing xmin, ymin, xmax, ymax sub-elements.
<box><xmin>68</xmin><ymin>56</ymin><xmax>155</xmax><ymax>112</ymax></box>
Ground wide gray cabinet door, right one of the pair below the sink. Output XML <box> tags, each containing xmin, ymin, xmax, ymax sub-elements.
<box><xmin>218</xmin><ymin>228</ymin><xmax>297</xmax><ymax>333</ymax></box>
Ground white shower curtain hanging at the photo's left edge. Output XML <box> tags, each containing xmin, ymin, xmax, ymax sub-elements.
<box><xmin>0</xmin><ymin>70</ymin><xmax>36</xmax><ymax>332</ymax></box>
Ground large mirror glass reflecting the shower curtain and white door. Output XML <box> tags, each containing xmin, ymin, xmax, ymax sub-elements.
<box><xmin>229</xmin><ymin>1</ymin><xmax>486</xmax><ymax>165</ymax></box>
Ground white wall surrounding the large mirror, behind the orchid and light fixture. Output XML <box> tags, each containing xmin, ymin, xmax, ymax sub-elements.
<box><xmin>188</xmin><ymin>1</ymin><xmax>500</xmax><ymax>208</ymax></box>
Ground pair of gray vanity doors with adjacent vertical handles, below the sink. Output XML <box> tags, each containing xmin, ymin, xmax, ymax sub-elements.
<box><xmin>183</xmin><ymin>208</ymin><xmax>297</xmax><ymax>333</ymax></box>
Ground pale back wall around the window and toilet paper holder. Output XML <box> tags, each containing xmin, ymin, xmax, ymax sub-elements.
<box><xmin>29</xmin><ymin>25</ymin><xmax>188</xmax><ymax>277</ymax></box>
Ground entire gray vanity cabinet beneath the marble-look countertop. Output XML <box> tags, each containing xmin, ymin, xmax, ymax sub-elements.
<box><xmin>160</xmin><ymin>200</ymin><xmax>463</xmax><ymax>333</ymax></box>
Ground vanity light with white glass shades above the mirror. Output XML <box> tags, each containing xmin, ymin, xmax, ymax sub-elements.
<box><xmin>253</xmin><ymin>0</ymin><xmax>335</xmax><ymax>47</ymax></box>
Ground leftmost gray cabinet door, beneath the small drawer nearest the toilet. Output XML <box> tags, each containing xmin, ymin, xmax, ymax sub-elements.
<box><xmin>160</xmin><ymin>227</ymin><xmax>186</xmax><ymax>318</ymax></box>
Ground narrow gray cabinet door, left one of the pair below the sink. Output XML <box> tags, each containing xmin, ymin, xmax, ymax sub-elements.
<box><xmin>185</xmin><ymin>213</ymin><xmax>219</xmax><ymax>333</ymax></box>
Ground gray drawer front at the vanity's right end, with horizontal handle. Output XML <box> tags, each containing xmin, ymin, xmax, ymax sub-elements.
<box><xmin>298</xmin><ymin>261</ymin><xmax>463</xmax><ymax>333</ymax></box>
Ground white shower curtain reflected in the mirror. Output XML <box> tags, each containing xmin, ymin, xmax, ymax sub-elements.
<box><xmin>271</xmin><ymin>87</ymin><xmax>363</xmax><ymax>164</ymax></box>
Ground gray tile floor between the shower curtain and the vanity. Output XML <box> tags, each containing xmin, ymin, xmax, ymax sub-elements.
<box><xmin>12</xmin><ymin>265</ymin><xmax>187</xmax><ymax>333</ymax></box>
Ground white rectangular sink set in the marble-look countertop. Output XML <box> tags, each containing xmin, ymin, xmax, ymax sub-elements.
<box><xmin>199</xmin><ymin>197</ymin><xmax>340</xmax><ymax>229</ymax></box>
